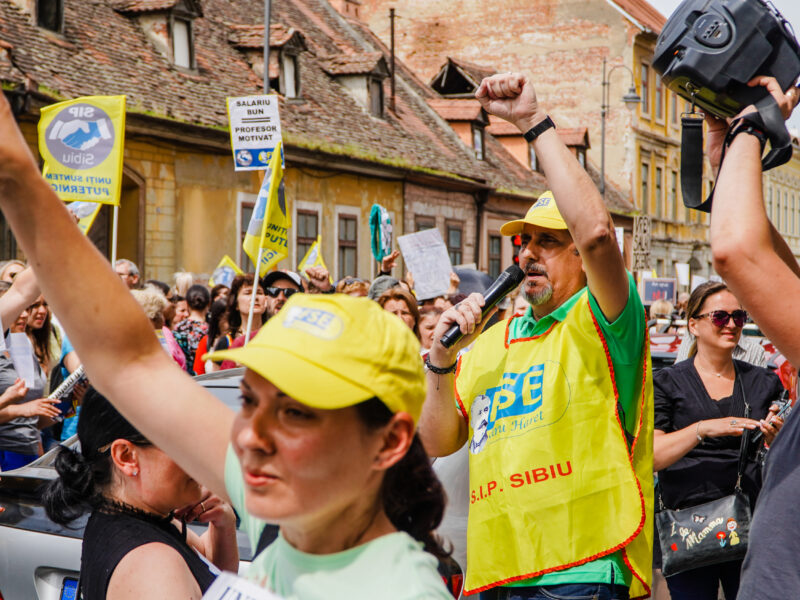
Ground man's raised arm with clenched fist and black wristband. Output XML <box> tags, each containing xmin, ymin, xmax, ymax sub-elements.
<box><xmin>475</xmin><ymin>73</ymin><xmax>628</xmax><ymax>322</ymax></box>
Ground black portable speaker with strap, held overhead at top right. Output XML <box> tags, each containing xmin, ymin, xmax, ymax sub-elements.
<box><xmin>653</xmin><ymin>0</ymin><xmax>800</xmax><ymax>210</ymax></box>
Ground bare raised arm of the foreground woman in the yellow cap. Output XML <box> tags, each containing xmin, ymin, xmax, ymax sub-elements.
<box><xmin>0</xmin><ymin>94</ymin><xmax>233</xmax><ymax>498</ymax></box>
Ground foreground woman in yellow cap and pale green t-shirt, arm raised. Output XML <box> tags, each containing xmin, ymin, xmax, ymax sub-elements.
<box><xmin>0</xmin><ymin>95</ymin><xmax>451</xmax><ymax>600</ymax></box>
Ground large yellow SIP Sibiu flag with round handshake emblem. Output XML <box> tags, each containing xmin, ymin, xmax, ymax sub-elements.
<box><xmin>39</xmin><ymin>96</ymin><xmax>125</xmax><ymax>204</ymax></box>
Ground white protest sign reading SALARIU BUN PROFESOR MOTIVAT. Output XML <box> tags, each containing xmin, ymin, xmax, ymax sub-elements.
<box><xmin>228</xmin><ymin>94</ymin><xmax>281</xmax><ymax>171</ymax></box>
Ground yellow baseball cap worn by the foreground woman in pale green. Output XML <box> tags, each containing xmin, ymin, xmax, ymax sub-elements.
<box><xmin>209</xmin><ymin>294</ymin><xmax>425</xmax><ymax>423</ymax></box>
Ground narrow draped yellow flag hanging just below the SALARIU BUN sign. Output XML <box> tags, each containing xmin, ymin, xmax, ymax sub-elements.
<box><xmin>242</xmin><ymin>142</ymin><xmax>292</xmax><ymax>277</ymax></box>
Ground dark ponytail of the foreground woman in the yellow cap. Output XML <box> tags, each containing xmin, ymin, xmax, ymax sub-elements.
<box><xmin>356</xmin><ymin>398</ymin><xmax>450</xmax><ymax>559</ymax></box>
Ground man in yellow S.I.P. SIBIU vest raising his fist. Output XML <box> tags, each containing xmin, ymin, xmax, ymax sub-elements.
<box><xmin>420</xmin><ymin>74</ymin><xmax>653</xmax><ymax>600</ymax></box>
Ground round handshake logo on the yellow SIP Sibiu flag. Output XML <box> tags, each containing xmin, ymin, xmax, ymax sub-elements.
<box><xmin>45</xmin><ymin>103</ymin><xmax>114</xmax><ymax>169</ymax></box>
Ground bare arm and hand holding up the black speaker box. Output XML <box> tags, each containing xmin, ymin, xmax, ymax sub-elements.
<box><xmin>709</xmin><ymin>78</ymin><xmax>800</xmax><ymax>365</ymax></box>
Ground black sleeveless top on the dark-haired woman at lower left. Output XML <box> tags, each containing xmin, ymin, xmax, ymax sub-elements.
<box><xmin>80</xmin><ymin>510</ymin><xmax>216</xmax><ymax>600</ymax></box>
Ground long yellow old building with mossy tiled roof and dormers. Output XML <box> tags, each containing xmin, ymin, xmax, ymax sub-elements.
<box><xmin>0</xmin><ymin>0</ymin><xmax>544</xmax><ymax>280</ymax></box>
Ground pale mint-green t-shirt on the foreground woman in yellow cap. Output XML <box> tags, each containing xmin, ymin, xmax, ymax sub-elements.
<box><xmin>225</xmin><ymin>446</ymin><xmax>453</xmax><ymax>600</ymax></box>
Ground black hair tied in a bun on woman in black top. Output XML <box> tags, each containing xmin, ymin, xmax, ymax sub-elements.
<box><xmin>42</xmin><ymin>387</ymin><xmax>150</xmax><ymax>525</ymax></box>
